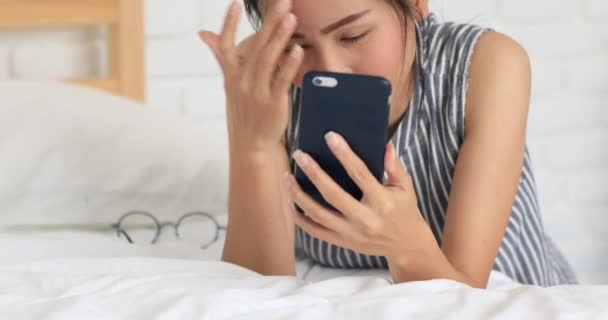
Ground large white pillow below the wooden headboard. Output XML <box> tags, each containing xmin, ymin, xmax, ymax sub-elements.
<box><xmin>0</xmin><ymin>81</ymin><xmax>228</xmax><ymax>227</ymax></box>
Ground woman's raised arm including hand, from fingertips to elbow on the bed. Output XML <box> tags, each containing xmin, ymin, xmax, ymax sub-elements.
<box><xmin>199</xmin><ymin>1</ymin><xmax>304</xmax><ymax>275</ymax></box>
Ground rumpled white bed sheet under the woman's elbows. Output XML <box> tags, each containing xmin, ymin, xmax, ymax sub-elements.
<box><xmin>0</xmin><ymin>226</ymin><xmax>608</xmax><ymax>319</ymax></box>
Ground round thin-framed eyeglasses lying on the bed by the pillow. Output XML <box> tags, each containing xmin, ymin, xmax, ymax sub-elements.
<box><xmin>111</xmin><ymin>210</ymin><xmax>226</xmax><ymax>249</ymax></box>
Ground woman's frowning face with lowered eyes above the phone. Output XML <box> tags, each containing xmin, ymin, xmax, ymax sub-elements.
<box><xmin>262</xmin><ymin>0</ymin><xmax>426</xmax><ymax>124</ymax></box>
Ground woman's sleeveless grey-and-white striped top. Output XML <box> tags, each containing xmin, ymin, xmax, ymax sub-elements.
<box><xmin>287</xmin><ymin>14</ymin><xmax>576</xmax><ymax>287</ymax></box>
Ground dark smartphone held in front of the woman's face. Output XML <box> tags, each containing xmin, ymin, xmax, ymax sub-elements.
<box><xmin>292</xmin><ymin>71</ymin><xmax>391</xmax><ymax>212</ymax></box>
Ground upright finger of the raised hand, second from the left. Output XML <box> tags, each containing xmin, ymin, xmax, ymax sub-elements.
<box><xmin>218</xmin><ymin>1</ymin><xmax>241</xmax><ymax>72</ymax></box>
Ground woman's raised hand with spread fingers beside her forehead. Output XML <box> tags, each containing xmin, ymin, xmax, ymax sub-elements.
<box><xmin>200</xmin><ymin>0</ymin><xmax>303</xmax><ymax>151</ymax></box>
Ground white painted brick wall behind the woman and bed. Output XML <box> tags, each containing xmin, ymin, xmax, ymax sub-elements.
<box><xmin>0</xmin><ymin>0</ymin><xmax>608</xmax><ymax>283</ymax></box>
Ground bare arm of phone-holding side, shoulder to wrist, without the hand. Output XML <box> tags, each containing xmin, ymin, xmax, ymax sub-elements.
<box><xmin>392</xmin><ymin>33</ymin><xmax>531</xmax><ymax>287</ymax></box>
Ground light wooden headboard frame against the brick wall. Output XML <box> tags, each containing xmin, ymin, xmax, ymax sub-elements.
<box><xmin>0</xmin><ymin>0</ymin><xmax>145</xmax><ymax>101</ymax></box>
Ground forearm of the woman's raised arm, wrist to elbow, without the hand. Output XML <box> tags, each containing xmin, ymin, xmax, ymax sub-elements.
<box><xmin>222</xmin><ymin>145</ymin><xmax>295</xmax><ymax>275</ymax></box>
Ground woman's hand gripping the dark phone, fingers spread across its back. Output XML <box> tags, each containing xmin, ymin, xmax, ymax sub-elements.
<box><xmin>287</xmin><ymin>132</ymin><xmax>438</xmax><ymax>265</ymax></box>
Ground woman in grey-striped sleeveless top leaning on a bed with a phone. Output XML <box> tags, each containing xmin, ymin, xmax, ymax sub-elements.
<box><xmin>200</xmin><ymin>0</ymin><xmax>576</xmax><ymax>288</ymax></box>
